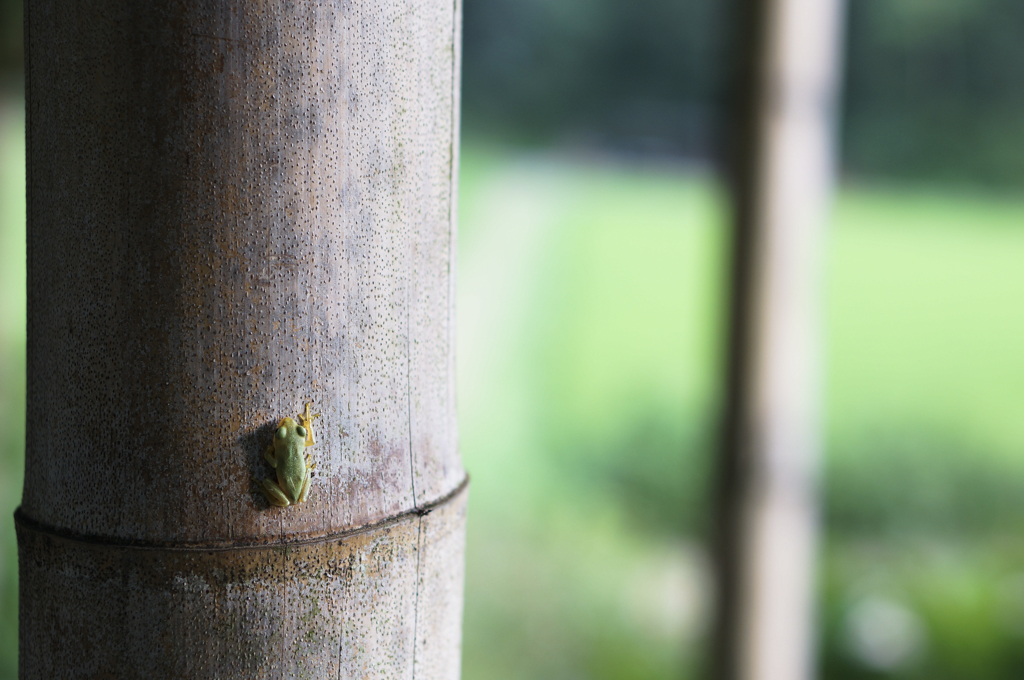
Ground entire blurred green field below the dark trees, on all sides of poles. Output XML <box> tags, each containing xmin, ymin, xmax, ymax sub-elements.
<box><xmin>0</xmin><ymin>105</ymin><xmax>1024</xmax><ymax>680</ymax></box>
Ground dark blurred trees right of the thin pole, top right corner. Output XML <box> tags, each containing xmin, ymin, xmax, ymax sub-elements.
<box><xmin>843</xmin><ymin>0</ymin><xmax>1024</xmax><ymax>187</ymax></box>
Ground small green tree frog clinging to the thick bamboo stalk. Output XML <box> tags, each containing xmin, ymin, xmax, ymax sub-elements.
<box><xmin>256</xmin><ymin>403</ymin><xmax>319</xmax><ymax>508</ymax></box>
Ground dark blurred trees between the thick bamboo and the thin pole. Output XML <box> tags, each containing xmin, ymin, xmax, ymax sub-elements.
<box><xmin>463</xmin><ymin>0</ymin><xmax>728</xmax><ymax>157</ymax></box>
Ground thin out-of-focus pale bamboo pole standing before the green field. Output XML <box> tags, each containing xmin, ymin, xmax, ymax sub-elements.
<box><xmin>712</xmin><ymin>0</ymin><xmax>843</xmax><ymax>680</ymax></box>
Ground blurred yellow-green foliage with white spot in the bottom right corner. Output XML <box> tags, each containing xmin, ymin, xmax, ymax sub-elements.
<box><xmin>821</xmin><ymin>536</ymin><xmax>1024</xmax><ymax>680</ymax></box>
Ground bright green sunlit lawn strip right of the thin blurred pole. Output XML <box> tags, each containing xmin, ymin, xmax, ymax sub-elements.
<box><xmin>827</xmin><ymin>188</ymin><xmax>1024</xmax><ymax>458</ymax></box>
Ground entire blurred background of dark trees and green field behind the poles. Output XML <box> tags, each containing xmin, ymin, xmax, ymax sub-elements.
<box><xmin>0</xmin><ymin>0</ymin><xmax>1024</xmax><ymax>680</ymax></box>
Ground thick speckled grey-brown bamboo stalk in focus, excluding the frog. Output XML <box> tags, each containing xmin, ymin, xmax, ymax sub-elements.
<box><xmin>17</xmin><ymin>0</ymin><xmax>465</xmax><ymax>678</ymax></box>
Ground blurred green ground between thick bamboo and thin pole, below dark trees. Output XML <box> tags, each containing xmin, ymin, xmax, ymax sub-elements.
<box><xmin>458</xmin><ymin>148</ymin><xmax>723</xmax><ymax>680</ymax></box>
